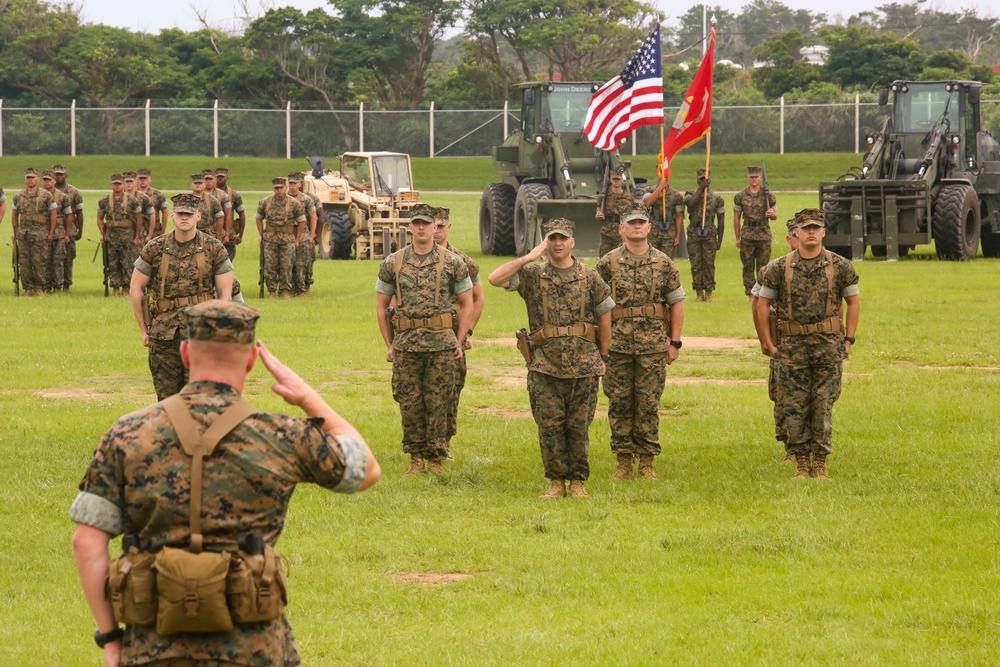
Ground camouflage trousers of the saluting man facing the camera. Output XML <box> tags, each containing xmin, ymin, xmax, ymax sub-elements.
<box><xmin>528</xmin><ymin>371</ymin><xmax>600</xmax><ymax>480</ymax></box>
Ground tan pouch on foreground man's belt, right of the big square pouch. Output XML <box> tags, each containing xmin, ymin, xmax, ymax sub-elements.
<box><xmin>226</xmin><ymin>545</ymin><xmax>288</xmax><ymax>623</ymax></box>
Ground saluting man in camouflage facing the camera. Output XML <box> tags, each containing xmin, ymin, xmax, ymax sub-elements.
<box><xmin>489</xmin><ymin>218</ymin><xmax>615</xmax><ymax>500</ymax></box>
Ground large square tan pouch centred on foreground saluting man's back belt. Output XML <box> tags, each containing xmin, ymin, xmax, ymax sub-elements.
<box><xmin>156</xmin><ymin>547</ymin><xmax>233</xmax><ymax>635</ymax></box>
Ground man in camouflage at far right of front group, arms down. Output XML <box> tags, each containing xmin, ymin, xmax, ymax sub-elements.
<box><xmin>756</xmin><ymin>209</ymin><xmax>861</xmax><ymax>477</ymax></box>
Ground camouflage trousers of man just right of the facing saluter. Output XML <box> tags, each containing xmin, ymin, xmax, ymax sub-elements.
<box><xmin>604</xmin><ymin>352</ymin><xmax>667</xmax><ymax>456</ymax></box>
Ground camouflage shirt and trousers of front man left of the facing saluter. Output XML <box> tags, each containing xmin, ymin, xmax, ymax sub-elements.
<box><xmin>375</xmin><ymin>244</ymin><xmax>472</xmax><ymax>461</ymax></box>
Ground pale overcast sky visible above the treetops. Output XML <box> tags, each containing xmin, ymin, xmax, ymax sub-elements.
<box><xmin>74</xmin><ymin>0</ymin><xmax>998</xmax><ymax>33</ymax></box>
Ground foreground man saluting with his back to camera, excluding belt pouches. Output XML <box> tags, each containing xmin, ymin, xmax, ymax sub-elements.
<box><xmin>69</xmin><ymin>301</ymin><xmax>380</xmax><ymax>667</ymax></box>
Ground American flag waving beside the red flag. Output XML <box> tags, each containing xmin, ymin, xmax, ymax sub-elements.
<box><xmin>583</xmin><ymin>25</ymin><xmax>663</xmax><ymax>151</ymax></box>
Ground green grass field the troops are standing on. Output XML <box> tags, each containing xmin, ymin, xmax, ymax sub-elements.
<box><xmin>0</xmin><ymin>156</ymin><xmax>1000</xmax><ymax>667</ymax></box>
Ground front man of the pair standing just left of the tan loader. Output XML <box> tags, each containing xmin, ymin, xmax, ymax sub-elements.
<box><xmin>257</xmin><ymin>178</ymin><xmax>306</xmax><ymax>299</ymax></box>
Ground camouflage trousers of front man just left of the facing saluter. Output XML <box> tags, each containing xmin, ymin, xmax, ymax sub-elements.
<box><xmin>392</xmin><ymin>350</ymin><xmax>455</xmax><ymax>461</ymax></box>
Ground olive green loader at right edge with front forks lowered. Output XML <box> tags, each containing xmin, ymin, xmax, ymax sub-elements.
<box><xmin>819</xmin><ymin>81</ymin><xmax>1000</xmax><ymax>260</ymax></box>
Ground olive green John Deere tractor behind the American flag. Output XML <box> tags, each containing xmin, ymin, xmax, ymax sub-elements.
<box><xmin>479</xmin><ymin>82</ymin><xmax>645</xmax><ymax>257</ymax></box>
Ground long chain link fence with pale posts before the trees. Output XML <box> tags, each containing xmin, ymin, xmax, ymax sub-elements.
<box><xmin>0</xmin><ymin>100</ymin><xmax>1000</xmax><ymax>157</ymax></box>
